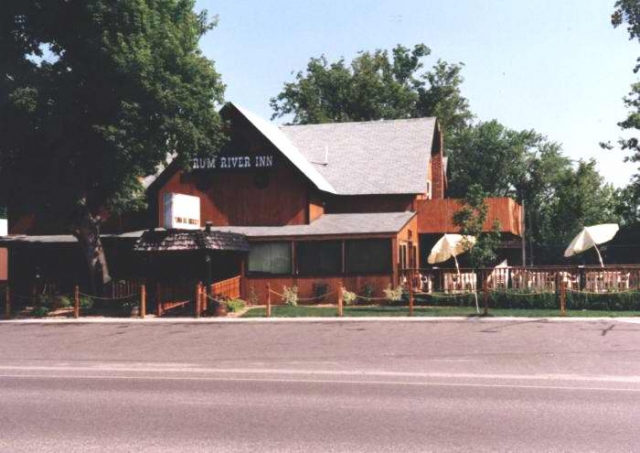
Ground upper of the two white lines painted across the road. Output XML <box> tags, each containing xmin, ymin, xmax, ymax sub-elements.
<box><xmin>0</xmin><ymin>364</ymin><xmax>640</xmax><ymax>384</ymax></box>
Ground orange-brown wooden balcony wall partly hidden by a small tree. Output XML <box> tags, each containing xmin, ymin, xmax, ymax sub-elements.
<box><xmin>418</xmin><ymin>197</ymin><xmax>522</xmax><ymax>236</ymax></box>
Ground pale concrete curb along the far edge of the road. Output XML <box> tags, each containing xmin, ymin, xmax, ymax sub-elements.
<box><xmin>0</xmin><ymin>316</ymin><xmax>640</xmax><ymax>326</ymax></box>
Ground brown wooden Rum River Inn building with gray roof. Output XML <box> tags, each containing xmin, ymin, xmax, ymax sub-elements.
<box><xmin>0</xmin><ymin>104</ymin><xmax>522</xmax><ymax>308</ymax></box>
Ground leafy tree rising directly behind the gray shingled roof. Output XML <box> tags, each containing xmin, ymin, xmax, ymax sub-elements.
<box><xmin>271</xmin><ymin>44</ymin><xmax>472</xmax><ymax>136</ymax></box>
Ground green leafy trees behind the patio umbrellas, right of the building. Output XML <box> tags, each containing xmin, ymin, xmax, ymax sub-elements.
<box><xmin>448</xmin><ymin>120</ymin><xmax>620</xmax><ymax>263</ymax></box>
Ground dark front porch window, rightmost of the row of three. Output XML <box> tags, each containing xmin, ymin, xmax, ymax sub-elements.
<box><xmin>345</xmin><ymin>239</ymin><xmax>392</xmax><ymax>274</ymax></box>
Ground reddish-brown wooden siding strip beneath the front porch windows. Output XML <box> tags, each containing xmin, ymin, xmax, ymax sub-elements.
<box><xmin>242</xmin><ymin>274</ymin><xmax>394</xmax><ymax>305</ymax></box>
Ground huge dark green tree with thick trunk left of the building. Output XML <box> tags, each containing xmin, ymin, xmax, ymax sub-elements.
<box><xmin>0</xmin><ymin>0</ymin><xmax>224</xmax><ymax>290</ymax></box>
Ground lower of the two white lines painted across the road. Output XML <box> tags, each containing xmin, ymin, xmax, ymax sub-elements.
<box><xmin>0</xmin><ymin>374</ymin><xmax>640</xmax><ymax>393</ymax></box>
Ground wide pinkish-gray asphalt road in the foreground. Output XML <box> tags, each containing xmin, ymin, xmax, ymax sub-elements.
<box><xmin>0</xmin><ymin>321</ymin><xmax>640</xmax><ymax>453</ymax></box>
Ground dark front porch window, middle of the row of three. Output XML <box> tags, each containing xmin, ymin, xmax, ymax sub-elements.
<box><xmin>296</xmin><ymin>241</ymin><xmax>342</xmax><ymax>275</ymax></box>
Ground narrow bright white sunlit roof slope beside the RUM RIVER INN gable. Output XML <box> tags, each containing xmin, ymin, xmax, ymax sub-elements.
<box><xmin>229</xmin><ymin>103</ymin><xmax>336</xmax><ymax>193</ymax></box>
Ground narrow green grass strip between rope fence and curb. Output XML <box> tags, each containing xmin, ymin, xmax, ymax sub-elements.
<box><xmin>242</xmin><ymin>305</ymin><xmax>640</xmax><ymax>318</ymax></box>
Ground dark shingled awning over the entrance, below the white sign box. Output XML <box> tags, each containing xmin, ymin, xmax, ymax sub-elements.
<box><xmin>133</xmin><ymin>230</ymin><xmax>249</xmax><ymax>252</ymax></box>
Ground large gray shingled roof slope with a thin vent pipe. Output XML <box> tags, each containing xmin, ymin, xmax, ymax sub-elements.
<box><xmin>280</xmin><ymin>118</ymin><xmax>436</xmax><ymax>195</ymax></box>
